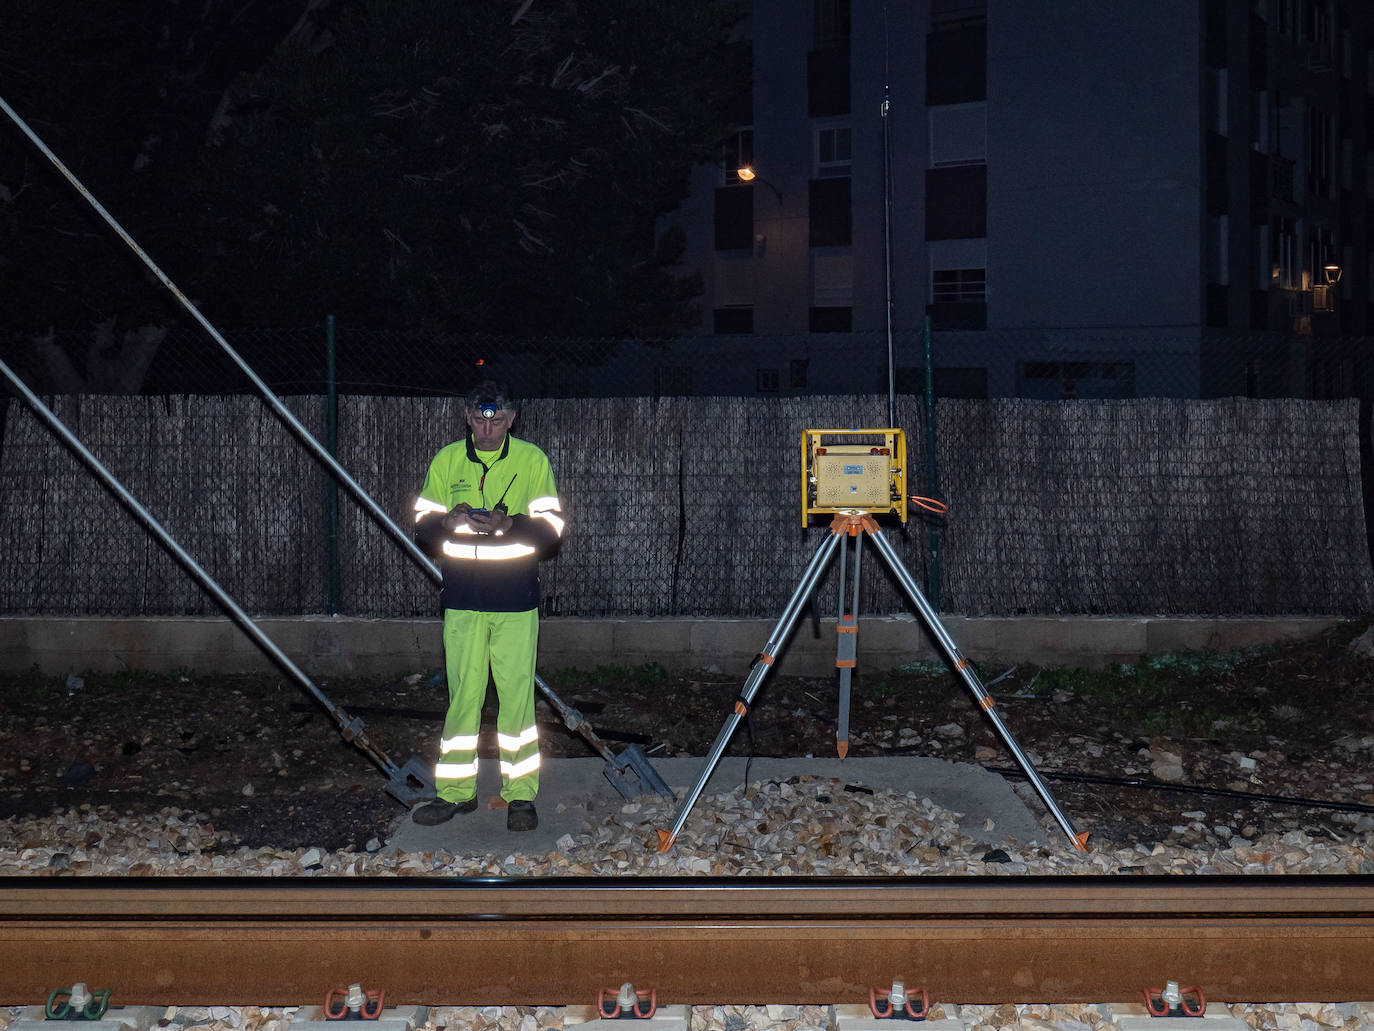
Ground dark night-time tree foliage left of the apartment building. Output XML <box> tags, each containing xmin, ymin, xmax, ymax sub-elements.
<box><xmin>0</xmin><ymin>0</ymin><xmax>749</xmax><ymax>390</ymax></box>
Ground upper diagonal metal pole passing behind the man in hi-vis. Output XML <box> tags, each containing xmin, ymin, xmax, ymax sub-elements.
<box><xmin>0</xmin><ymin>96</ymin><xmax>671</xmax><ymax>795</ymax></box>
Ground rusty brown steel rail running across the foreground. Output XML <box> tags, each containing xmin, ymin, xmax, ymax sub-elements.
<box><xmin>0</xmin><ymin>876</ymin><xmax>1374</xmax><ymax>1005</ymax></box>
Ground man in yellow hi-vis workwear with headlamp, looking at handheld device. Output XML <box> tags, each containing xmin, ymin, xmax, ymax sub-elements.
<box><xmin>412</xmin><ymin>379</ymin><xmax>563</xmax><ymax>830</ymax></box>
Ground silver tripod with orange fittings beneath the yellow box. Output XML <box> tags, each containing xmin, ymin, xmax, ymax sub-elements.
<box><xmin>658</xmin><ymin>510</ymin><xmax>1088</xmax><ymax>852</ymax></box>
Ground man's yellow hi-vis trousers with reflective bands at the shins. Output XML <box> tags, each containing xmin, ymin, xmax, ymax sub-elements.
<box><xmin>434</xmin><ymin>609</ymin><xmax>539</xmax><ymax>801</ymax></box>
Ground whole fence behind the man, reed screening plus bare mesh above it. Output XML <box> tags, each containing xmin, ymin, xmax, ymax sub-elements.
<box><xmin>0</xmin><ymin>323</ymin><xmax>1374</xmax><ymax>617</ymax></box>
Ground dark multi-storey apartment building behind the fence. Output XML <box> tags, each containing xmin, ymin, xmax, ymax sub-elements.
<box><xmin>662</xmin><ymin>0</ymin><xmax>1374</xmax><ymax>397</ymax></box>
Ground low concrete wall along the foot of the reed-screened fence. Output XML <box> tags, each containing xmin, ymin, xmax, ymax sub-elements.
<box><xmin>0</xmin><ymin>616</ymin><xmax>1341</xmax><ymax>676</ymax></box>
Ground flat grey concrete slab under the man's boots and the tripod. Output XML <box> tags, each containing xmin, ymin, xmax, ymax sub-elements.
<box><xmin>387</xmin><ymin>756</ymin><xmax>1046</xmax><ymax>855</ymax></box>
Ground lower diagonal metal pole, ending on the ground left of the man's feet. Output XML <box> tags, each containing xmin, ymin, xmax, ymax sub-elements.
<box><xmin>0</xmin><ymin>362</ymin><xmax>433</xmax><ymax>804</ymax></box>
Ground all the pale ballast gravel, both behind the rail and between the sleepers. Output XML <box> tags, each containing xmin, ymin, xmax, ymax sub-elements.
<box><xmin>0</xmin><ymin>777</ymin><xmax>1374</xmax><ymax>1031</ymax></box>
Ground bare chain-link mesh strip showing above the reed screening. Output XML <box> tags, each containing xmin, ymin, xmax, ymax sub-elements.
<box><xmin>4</xmin><ymin>319</ymin><xmax>1374</xmax><ymax>400</ymax></box>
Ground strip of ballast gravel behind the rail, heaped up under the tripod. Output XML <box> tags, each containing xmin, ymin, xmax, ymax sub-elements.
<box><xmin>0</xmin><ymin>777</ymin><xmax>1374</xmax><ymax>877</ymax></box>
